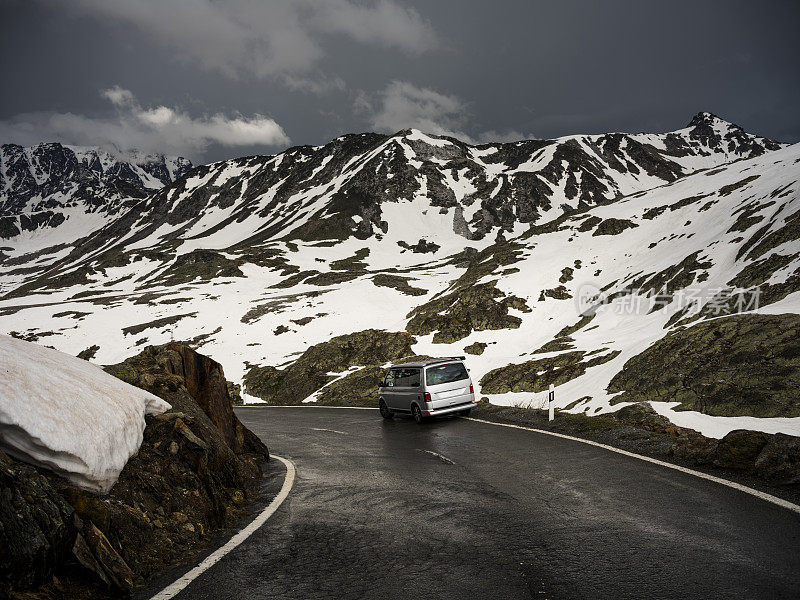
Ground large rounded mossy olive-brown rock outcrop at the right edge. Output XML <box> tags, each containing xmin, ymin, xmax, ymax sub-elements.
<box><xmin>608</xmin><ymin>314</ymin><xmax>800</xmax><ymax>417</ymax></box>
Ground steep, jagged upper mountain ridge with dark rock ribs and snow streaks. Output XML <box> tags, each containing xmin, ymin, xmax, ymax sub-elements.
<box><xmin>42</xmin><ymin>113</ymin><xmax>780</xmax><ymax>253</ymax></box>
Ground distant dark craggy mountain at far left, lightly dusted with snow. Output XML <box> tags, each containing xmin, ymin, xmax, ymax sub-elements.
<box><xmin>0</xmin><ymin>143</ymin><xmax>192</xmax><ymax>240</ymax></box>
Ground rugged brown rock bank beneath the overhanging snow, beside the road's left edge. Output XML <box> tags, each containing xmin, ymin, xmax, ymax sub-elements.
<box><xmin>0</xmin><ymin>343</ymin><xmax>268</xmax><ymax>599</ymax></box>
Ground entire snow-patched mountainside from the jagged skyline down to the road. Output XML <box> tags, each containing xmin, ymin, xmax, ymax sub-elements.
<box><xmin>0</xmin><ymin>113</ymin><xmax>800</xmax><ymax>435</ymax></box>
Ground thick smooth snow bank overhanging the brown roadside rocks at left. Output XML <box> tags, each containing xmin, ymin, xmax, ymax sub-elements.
<box><xmin>0</xmin><ymin>335</ymin><xmax>170</xmax><ymax>494</ymax></box>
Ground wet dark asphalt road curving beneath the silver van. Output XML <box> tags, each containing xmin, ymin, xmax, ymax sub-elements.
<box><xmin>139</xmin><ymin>407</ymin><xmax>800</xmax><ymax>600</ymax></box>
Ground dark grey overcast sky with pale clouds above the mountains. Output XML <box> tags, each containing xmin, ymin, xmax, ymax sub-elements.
<box><xmin>0</xmin><ymin>0</ymin><xmax>800</xmax><ymax>162</ymax></box>
